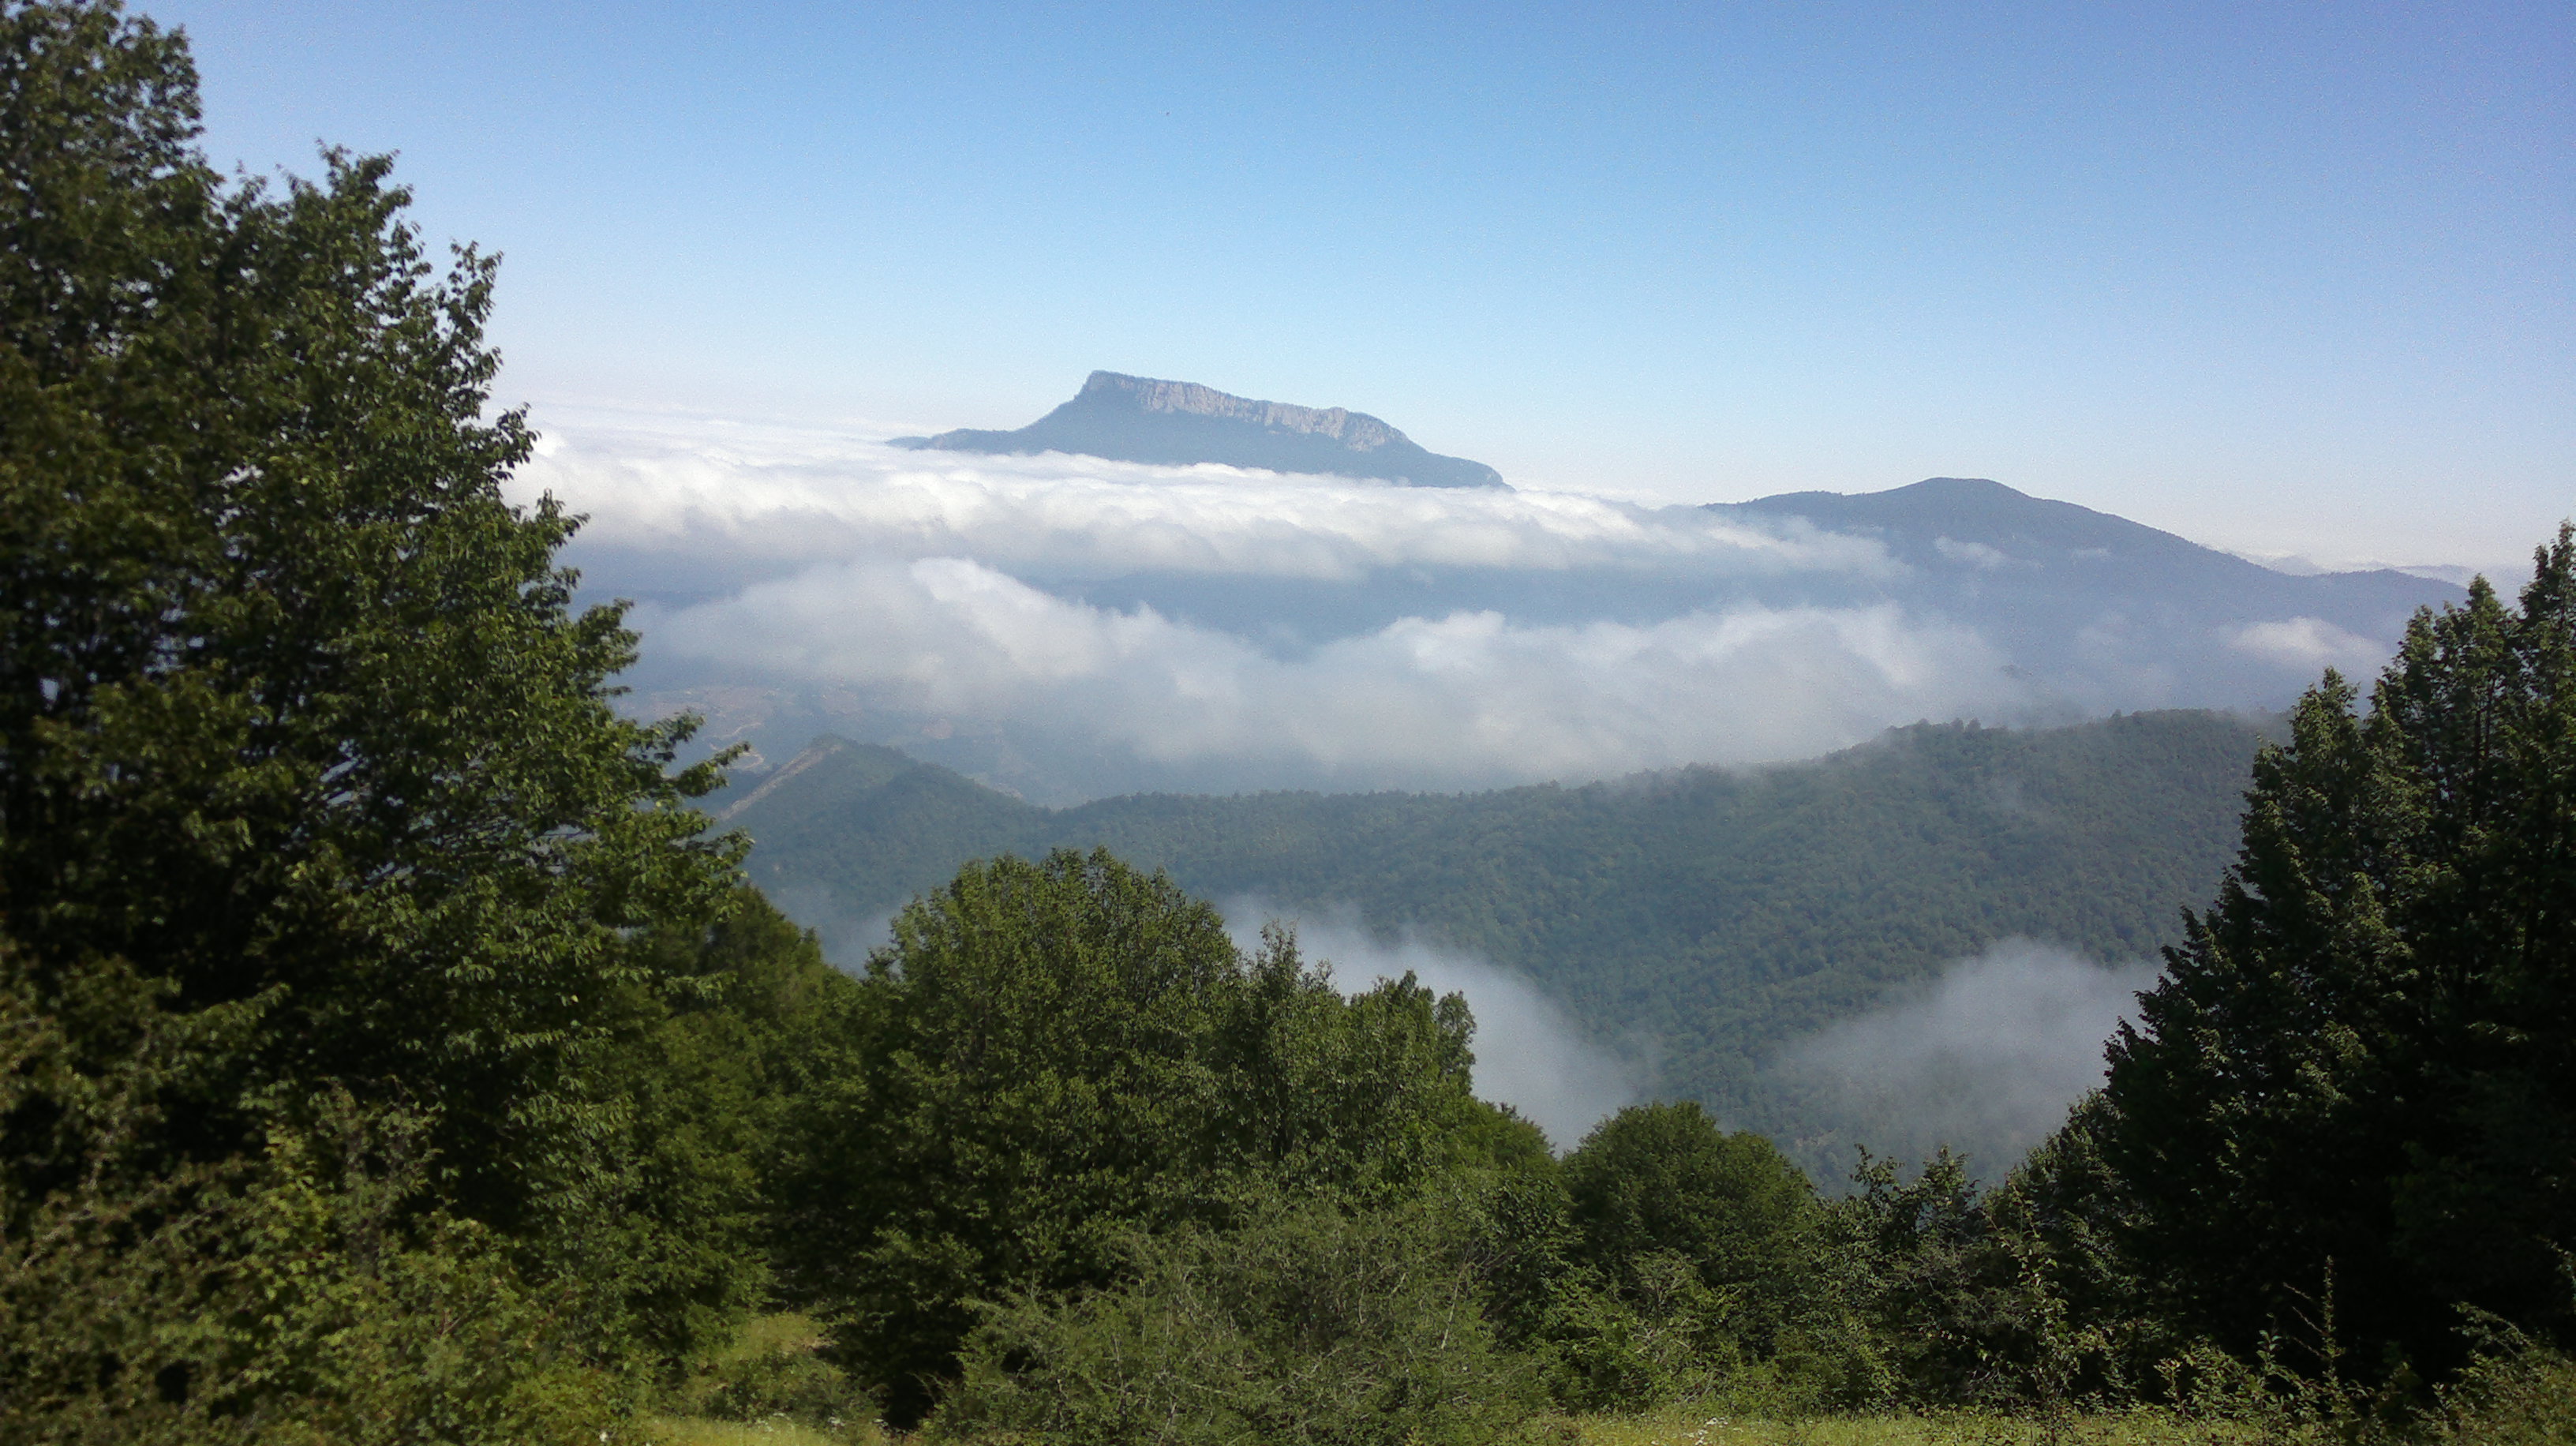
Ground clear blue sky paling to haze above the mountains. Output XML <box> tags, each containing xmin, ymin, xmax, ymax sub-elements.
<box><xmin>142</xmin><ymin>0</ymin><xmax>2576</xmax><ymax>564</ymax></box>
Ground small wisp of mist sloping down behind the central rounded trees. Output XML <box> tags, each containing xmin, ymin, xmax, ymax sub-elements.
<box><xmin>1223</xmin><ymin>900</ymin><xmax>1643</xmax><ymax>1152</ymax></box>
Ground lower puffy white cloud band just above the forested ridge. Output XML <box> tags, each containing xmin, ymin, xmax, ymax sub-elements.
<box><xmin>636</xmin><ymin>556</ymin><xmax>2017</xmax><ymax>786</ymax></box>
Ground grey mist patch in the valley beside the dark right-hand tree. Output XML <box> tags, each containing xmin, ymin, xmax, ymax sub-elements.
<box><xmin>1767</xmin><ymin>938</ymin><xmax>2156</xmax><ymax>1181</ymax></box>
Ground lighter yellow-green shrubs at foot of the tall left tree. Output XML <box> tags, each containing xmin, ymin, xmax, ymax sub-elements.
<box><xmin>0</xmin><ymin>941</ymin><xmax>621</xmax><ymax>1446</ymax></box>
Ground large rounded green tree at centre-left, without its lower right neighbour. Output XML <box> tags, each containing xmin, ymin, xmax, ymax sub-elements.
<box><xmin>786</xmin><ymin>853</ymin><xmax>1237</xmax><ymax>1420</ymax></box>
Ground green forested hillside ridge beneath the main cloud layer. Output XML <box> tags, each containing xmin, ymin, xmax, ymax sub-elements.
<box><xmin>732</xmin><ymin>711</ymin><xmax>2262</xmax><ymax>1134</ymax></box>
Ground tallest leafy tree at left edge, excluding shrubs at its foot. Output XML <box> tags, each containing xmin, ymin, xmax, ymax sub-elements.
<box><xmin>0</xmin><ymin>2</ymin><xmax>734</xmax><ymax>1340</ymax></box>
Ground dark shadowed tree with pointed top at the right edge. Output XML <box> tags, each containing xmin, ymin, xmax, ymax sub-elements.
<box><xmin>2099</xmin><ymin>528</ymin><xmax>2576</xmax><ymax>1371</ymax></box>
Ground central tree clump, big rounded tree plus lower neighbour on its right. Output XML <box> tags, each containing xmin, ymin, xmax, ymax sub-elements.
<box><xmin>778</xmin><ymin>851</ymin><xmax>1510</xmax><ymax>1423</ymax></box>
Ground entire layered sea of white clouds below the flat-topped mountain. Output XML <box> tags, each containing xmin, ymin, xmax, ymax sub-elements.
<box><xmin>513</xmin><ymin>399</ymin><xmax>2385</xmax><ymax>802</ymax></box>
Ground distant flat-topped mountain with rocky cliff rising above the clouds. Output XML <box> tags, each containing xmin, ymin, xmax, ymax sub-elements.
<box><xmin>894</xmin><ymin>371</ymin><xmax>1502</xmax><ymax>487</ymax></box>
